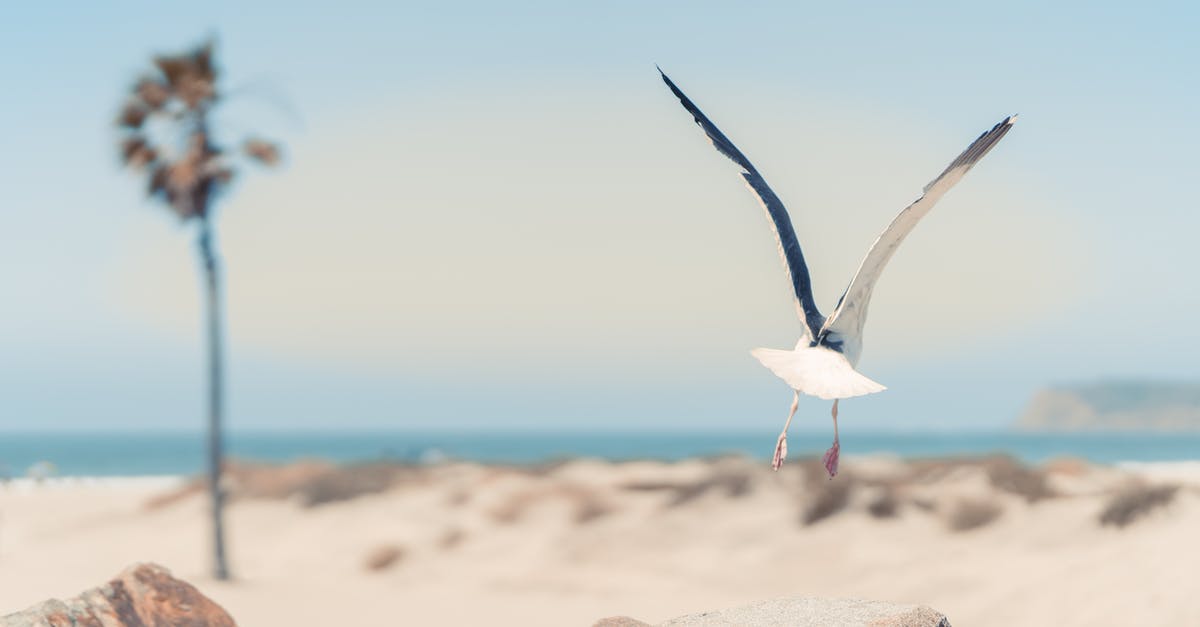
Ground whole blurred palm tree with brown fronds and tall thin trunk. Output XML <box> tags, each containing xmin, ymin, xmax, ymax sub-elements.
<box><xmin>116</xmin><ymin>42</ymin><xmax>280</xmax><ymax>580</ymax></box>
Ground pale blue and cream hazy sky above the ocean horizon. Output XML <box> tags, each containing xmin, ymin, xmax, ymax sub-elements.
<box><xmin>0</xmin><ymin>1</ymin><xmax>1200</xmax><ymax>434</ymax></box>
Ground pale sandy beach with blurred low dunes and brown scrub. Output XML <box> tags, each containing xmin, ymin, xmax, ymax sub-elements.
<box><xmin>0</xmin><ymin>458</ymin><xmax>1200</xmax><ymax>626</ymax></box>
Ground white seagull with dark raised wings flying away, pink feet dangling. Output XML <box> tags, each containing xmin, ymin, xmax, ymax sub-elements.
<box><xmin>659</xmin><ymin>67</ymin><xmax>1016</xmax><ymax>479</ymax></box>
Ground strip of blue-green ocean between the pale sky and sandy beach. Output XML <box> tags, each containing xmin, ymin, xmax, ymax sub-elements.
<box><xmin>0</xmin><ymin>430</ymin><xmax>1200</xmax><ymax>478</ymax></box>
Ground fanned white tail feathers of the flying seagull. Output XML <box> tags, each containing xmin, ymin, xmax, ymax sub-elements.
<box><xmin>750</xmin><ymin>346</ymin><xmax>887</xmax><ymax>400</ymax></box>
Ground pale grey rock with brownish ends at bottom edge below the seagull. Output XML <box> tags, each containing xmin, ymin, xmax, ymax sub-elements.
<box><xmin>614</xmin><ymin>597</ymin><xmax>950</xmax><ymax>627</ymax></box>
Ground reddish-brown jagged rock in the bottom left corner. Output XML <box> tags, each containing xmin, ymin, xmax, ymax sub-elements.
<box><xmin>0</xmin><ymin>563</ymin><xmax>236</xmax><ymax>627</ymax></box>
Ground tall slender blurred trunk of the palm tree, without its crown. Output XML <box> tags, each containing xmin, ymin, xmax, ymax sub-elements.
<box><xmin>198</xmin><ymin>215</ymin><xmax>229</xmax><ymax>581</ymax></box>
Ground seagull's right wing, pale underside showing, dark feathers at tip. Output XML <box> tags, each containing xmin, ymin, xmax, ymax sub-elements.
<box><xmin>817</xmin><ymin>115</ymin><xmax>1016</xmax><ymax>338</ymax></box>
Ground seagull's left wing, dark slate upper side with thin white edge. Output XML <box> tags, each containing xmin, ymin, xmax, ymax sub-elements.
<box><xmin>659</xmin><ymin>68</ymin><xmax>824</xmax><ymax>338</ymax></box>
